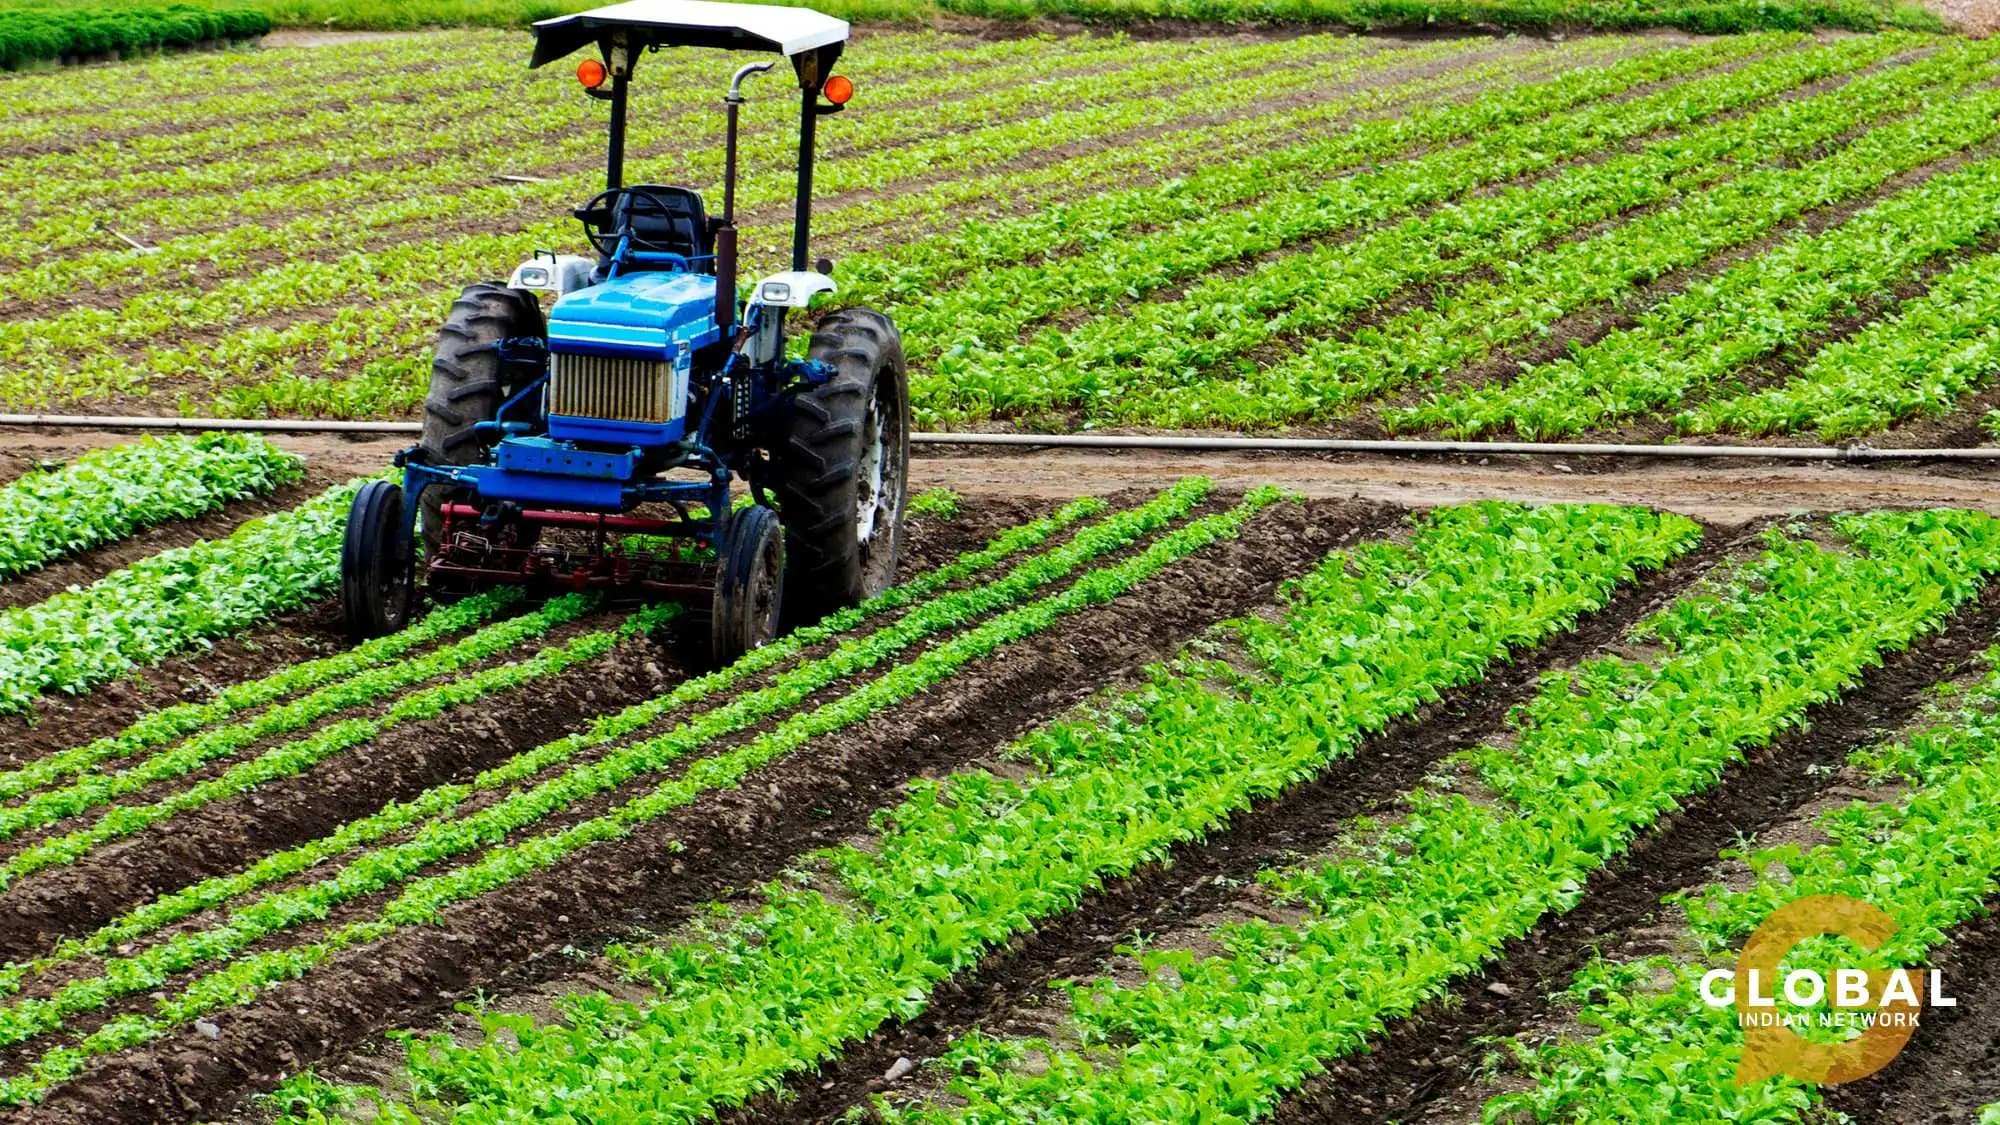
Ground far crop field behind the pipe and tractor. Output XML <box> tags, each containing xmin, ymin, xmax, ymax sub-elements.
<box><xmin>11</xmin><ymin>32</ymin><xmax>2000</xmax><ymax>446</ymax></box>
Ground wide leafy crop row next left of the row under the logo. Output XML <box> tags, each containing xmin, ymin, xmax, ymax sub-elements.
<box><xmin>868</xmin><ymin>510</ymin><xmax>2000</xmax><ymax>1121</ymax></box>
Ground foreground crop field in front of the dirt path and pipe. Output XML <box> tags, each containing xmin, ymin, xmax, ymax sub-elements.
<box><xmin>0</xmin><ymin>438</ymin><xmax>2000</xmax><ymax>1123</ymax></box>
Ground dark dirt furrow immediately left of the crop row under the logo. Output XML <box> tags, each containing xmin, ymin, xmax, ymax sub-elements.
<box><xmin>1276</xmin><ymin>568</ymin><xmax>2000</xmax><ymax>1123</ymax></box>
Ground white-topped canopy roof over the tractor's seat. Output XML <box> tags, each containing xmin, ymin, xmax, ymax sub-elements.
<box><xmin>528</xmin><ymin>0</ymin><xmax>848</xmax><ymax>66</ymax></box>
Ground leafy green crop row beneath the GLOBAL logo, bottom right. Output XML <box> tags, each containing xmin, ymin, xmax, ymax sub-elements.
<box><xmin>1486</xmin><ymin>653</ymin><xmax>2000</xmax><ymax>1121</ymax></box>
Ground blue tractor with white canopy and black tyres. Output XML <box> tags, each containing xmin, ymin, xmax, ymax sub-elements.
<box><xmin>342</xmin><ymin>0</ymin><xmax>910</xmax><ymax>665</ymax></box>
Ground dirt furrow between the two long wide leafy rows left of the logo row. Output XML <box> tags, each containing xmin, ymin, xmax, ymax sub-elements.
<box><xmin>756</xmin><ymin>512</ymin><xmax>1750</xmax><ymax>1121</ymax></box>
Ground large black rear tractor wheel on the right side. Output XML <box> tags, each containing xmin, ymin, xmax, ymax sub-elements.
<box><xmin>772</xmin><ymin>308</ymin><xmax>910</xmax><ymax>629</ymax></box>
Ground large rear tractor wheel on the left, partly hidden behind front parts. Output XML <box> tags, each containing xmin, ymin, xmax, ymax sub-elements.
<box><xmin>418</xmin><ymin>282</ymin><xmax>548</xmax><ymax>558</ymax></box>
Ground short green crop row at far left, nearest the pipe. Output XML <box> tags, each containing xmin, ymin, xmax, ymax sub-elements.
<box><xmin>0</xmin><ymin>434</ymin><xmax>306</xmax><ymax>579</ymax></box>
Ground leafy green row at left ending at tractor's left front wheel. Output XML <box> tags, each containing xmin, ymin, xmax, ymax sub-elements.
<box><xmin>0</xmin><ymin>472</ymin><xmax>360</xmax><ymax>713</ymax></box>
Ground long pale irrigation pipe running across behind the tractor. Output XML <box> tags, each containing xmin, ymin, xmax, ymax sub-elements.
<box><xmin>0</xmin><ymin>414</ymin><xmax>2000</xmax><ymax>460</ymax></box>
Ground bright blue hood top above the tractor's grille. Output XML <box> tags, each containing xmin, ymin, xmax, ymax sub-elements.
<box><xmin>548</xmin><ymin>270</ymin><xmax>722</xmax><ymax>358</ymax></box>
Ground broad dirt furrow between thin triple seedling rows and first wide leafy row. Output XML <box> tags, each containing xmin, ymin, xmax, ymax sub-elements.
<box><xmin>6</xmin><ymin>494</ymin><xmax>1388</xmax><ymax>1123</ymax></box>
